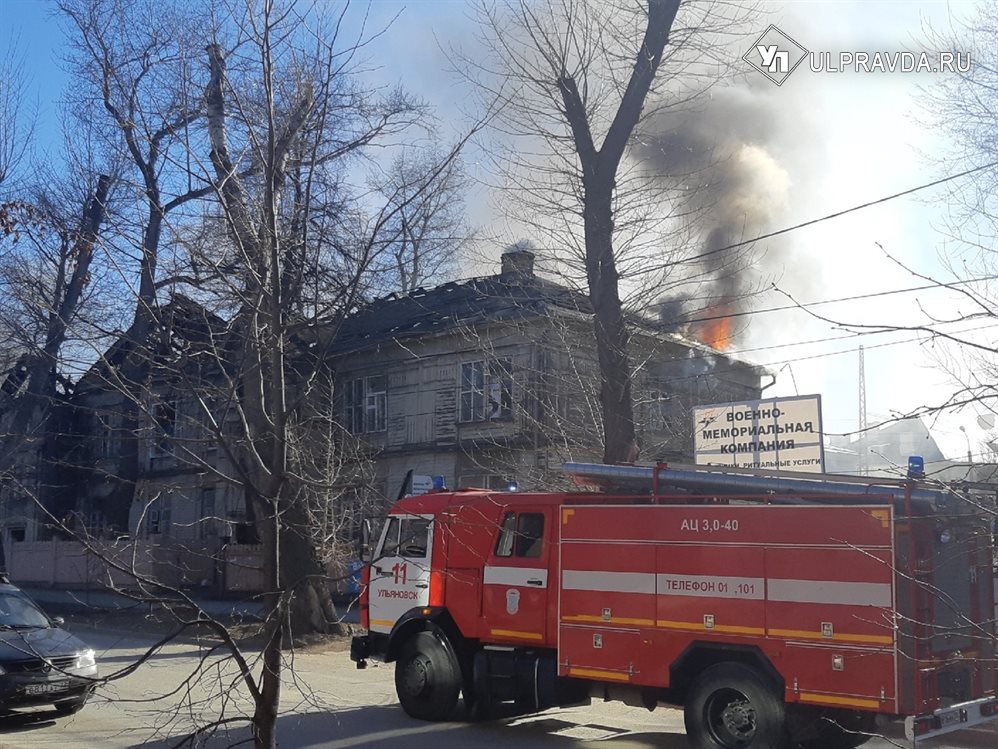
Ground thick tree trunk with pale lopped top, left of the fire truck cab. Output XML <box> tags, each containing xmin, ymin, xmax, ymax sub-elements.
<box><xmin>205</xmin><ymin>36</ymin><xmax>334</xmax><ymax>635</ymax></box>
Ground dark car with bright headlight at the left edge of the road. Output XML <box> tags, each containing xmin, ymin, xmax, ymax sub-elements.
<box><xmin>0</xmin><ymin>577</ymin><xmax>97</xmax><ymax>715</ymax></box>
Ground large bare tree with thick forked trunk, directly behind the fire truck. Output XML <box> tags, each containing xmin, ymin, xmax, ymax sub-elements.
<box><xmin>464</xmin><ymin>0</ymin><xmax>745</xmax><ymax>462</ymax></box>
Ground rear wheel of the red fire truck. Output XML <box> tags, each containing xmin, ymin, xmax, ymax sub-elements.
<box><xmin>684</xmin><ymin>662</ymin><xmax>790</xmax><ymax>749</ymax></box>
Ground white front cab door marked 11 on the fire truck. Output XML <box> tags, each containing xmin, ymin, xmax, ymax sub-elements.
<box><xmin>368</xmin><ymin>515</ymin><xmax>433</xmax><ymax>633</ymax></box>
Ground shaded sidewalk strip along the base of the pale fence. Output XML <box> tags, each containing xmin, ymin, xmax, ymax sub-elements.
<box><xmin>21</xmin><ymin>586</ymin><xmax>360</xmax><ymax>624</ymax></box>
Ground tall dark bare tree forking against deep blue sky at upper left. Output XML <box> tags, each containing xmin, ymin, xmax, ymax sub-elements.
<box><xmin>58</xmin><ymin>0</ymin><xmax>213</xmax><ymax>530</ymax></box>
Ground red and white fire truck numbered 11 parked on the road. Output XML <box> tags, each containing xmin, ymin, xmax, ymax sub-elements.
<box><xmin>351</xmin><ymin>464</ymin><xmax>998</xmax><ymax>749</ymax></box>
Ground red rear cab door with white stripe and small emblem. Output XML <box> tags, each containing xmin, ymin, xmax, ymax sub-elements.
<box><xmin>482</xmin><ymin>508</ymin><xmax>552</xmax><ymax>645</ymax></box>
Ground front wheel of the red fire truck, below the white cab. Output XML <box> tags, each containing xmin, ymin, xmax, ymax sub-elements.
<box><xmin>395</xmin><ymin>632</ymin><xmax>461</xmax><ymax>720</ymax></box>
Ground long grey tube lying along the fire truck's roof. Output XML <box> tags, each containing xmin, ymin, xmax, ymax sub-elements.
<box><xmin>562</xmin><ymin>463</ymin><xmax>954</xmax><ymax>510</ymax></box>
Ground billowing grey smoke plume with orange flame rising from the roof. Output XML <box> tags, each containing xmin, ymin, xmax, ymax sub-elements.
<box><xmin>634</xmin><ymin>86</ymin><xmax>790</xmax><ymax>349</ymax></box>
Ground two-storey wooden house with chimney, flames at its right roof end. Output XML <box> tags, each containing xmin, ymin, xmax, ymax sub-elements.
<box><xmin>329</xmin><ymin>250</ymin><xmax>762</xmax><ymax>492</ymax></box>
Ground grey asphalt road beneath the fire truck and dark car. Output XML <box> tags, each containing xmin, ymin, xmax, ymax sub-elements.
<box><xmin>0</xmin><ymin>624</ymin><xmax>998</xmax><ymax>749</ymax></box>
